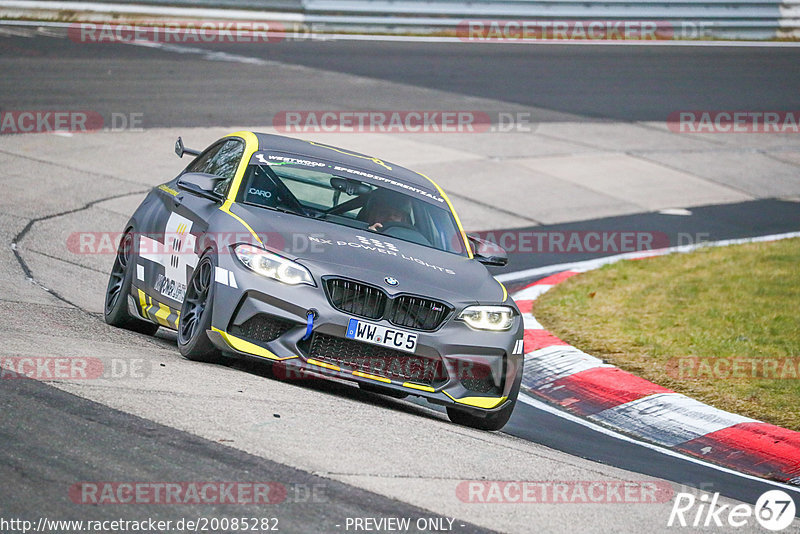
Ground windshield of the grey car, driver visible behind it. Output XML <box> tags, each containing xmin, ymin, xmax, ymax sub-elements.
<box><xmin>237</xmin><ymin>163</ymin><xmax>465</xmax><ymax>255</ymax></box>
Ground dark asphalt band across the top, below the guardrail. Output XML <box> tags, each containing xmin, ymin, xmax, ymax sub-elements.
<box><xmin>0</xmin><ymin>30</ymin><xmax>800</xmax><ymax>128</ymax></box>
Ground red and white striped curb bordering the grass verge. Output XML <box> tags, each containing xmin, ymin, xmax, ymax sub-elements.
<box><xmin>506</xmin><ymin>232</ymin><xmax>800</xmax><ymax>485</ymax></box>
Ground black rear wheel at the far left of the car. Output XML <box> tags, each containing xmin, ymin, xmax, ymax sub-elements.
<box><xmin>103</xmin><ymin>231</ymin><xmax>158</xmax><ymax>336</ymax></box>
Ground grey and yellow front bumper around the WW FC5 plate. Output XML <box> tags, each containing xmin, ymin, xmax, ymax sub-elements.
<box><xmin>208</xmin><ymin>256</ymin><xmax>523</xmax><ymax>415</ymax></box>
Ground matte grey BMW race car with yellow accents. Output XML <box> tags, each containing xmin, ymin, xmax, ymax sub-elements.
<box><xmin>105</xmin><ymin>132</ymin><xmax>523</xmax><ymax>430</ymax></box>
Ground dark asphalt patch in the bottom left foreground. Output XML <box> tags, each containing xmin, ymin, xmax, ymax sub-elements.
<box><xmin>0</xmin><ymin>380</ymin><xmax>487</xmax><ymax>533</ymax></box>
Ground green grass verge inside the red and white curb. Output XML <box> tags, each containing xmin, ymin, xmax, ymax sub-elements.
<box><xmin>533</xmin><ymin>239</ymin><xmax>800</xmax><ymax>430</ymax></box>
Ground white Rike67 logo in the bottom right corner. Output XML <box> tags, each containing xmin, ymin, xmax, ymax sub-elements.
<box><xmin>667</xmin><ymin>490</ymin><xmax>796</xmax><ymax>532</ymax></box>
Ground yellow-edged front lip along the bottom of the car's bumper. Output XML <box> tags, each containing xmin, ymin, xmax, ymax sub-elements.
<box><xmin>207</xmin><ymin>327</ymin><xmax>511</xmax><ymax>415</ymax></box>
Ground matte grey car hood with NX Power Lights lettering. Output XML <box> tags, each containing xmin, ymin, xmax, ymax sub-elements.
<box><xmin>231</xmin><ymin>205</ymin><xmax>505</xmax><ymax>304</ymax></box>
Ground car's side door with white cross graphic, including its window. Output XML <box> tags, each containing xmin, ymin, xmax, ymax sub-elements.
<box><xmin>140</xmin><ymin>138</ymin><xmax>244</xmax><ymax>318</ymax></box>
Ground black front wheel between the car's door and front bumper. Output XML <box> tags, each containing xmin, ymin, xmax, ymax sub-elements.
<box><xmin>178</xmin><ymin>251</ymin><xmax>223</xmax><ymax>363</ymax></box>
